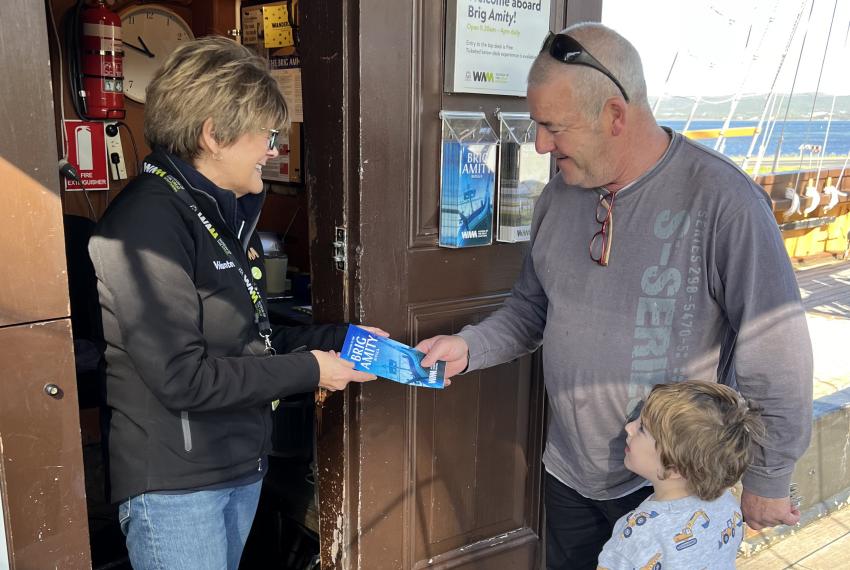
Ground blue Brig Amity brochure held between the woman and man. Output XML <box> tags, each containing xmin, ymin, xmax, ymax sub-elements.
<box><xmin>340</xmin><ymin>325</ymin><xmax>446</xmax><ymax>388</ymax></box>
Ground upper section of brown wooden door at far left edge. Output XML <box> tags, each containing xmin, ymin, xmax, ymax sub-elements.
<box><xmin>0</xmin><ymin>0</ymin><xmax>70</xmax><ymax>326</ymax></box>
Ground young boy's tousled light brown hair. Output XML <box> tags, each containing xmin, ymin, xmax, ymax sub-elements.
<box><xmin>640</xmin><ymin>380</ymin><xmax>763</xmax><ymax>501</ymax></box>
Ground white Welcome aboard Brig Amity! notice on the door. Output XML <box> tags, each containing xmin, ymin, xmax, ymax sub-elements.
<box><xmin>445</xmin><ymin>0</ymin><xmax>550</xmax><ymax>97</ymax></box>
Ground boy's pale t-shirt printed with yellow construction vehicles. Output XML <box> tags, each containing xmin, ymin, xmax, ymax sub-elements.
<box><xmin>599</xmin><ymin>490</ymin><xmax>744</xmax><ymax>570</ymax></box>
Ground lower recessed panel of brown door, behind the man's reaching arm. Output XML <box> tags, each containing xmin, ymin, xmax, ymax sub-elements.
<box><xmin>410</xmin><ymin>295</ymin><xmax>541</xmax><ymax>561</ymax></box>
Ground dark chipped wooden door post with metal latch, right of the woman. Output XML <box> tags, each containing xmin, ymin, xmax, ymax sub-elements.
<box><xmin>300</xmin><ymin>0</ymin><xmax>360</xmax><ymax>568</ymax></box>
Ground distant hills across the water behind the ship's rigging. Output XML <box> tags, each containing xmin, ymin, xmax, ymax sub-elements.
<box><xmin>649</xmin><ymin>93</ymin><xmax>850</xmax><ymax>121</ymax></box>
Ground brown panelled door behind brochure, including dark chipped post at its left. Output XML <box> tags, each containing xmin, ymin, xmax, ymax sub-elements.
<box><xmin>302</xmin><ymin>0</ymin><xmax>601</xmax><ymax>570</ymax></box>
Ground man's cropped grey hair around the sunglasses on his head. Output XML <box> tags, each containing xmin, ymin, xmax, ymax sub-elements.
<box><xmin>528</xmin><ymin>22</ymin><xmax>649</xmax><ymax>120</ymax></box>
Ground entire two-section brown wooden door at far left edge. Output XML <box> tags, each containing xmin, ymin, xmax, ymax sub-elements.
<box><xmin>0</xmin><ymin>0</ymin><xmax>91</xmax><ymax>569</ymax></box>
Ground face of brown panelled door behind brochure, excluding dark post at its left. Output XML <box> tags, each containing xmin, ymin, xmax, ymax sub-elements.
<box><xmin>348</xmin><ymin>0</ymin><xmax>548</xmax><ymax>570</ymax></box>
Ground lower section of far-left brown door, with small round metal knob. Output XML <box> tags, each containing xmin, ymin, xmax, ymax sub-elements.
<box><xmin>0</xmin><ymin>319</ymin><xmax>91</xmax><ymax>569</ymax></box>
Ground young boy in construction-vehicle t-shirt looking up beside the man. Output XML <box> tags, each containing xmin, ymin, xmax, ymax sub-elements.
<box><xmin>599</xmin><ymin>381</ymin><xmax>763</xmax><ymax>570</ymax></box>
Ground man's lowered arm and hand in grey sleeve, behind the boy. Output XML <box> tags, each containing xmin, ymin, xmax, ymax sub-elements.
<box><xmin>715</xmin><ymin>189</ymin><xmax>813</xmax><ymax>529</ymax></box>
